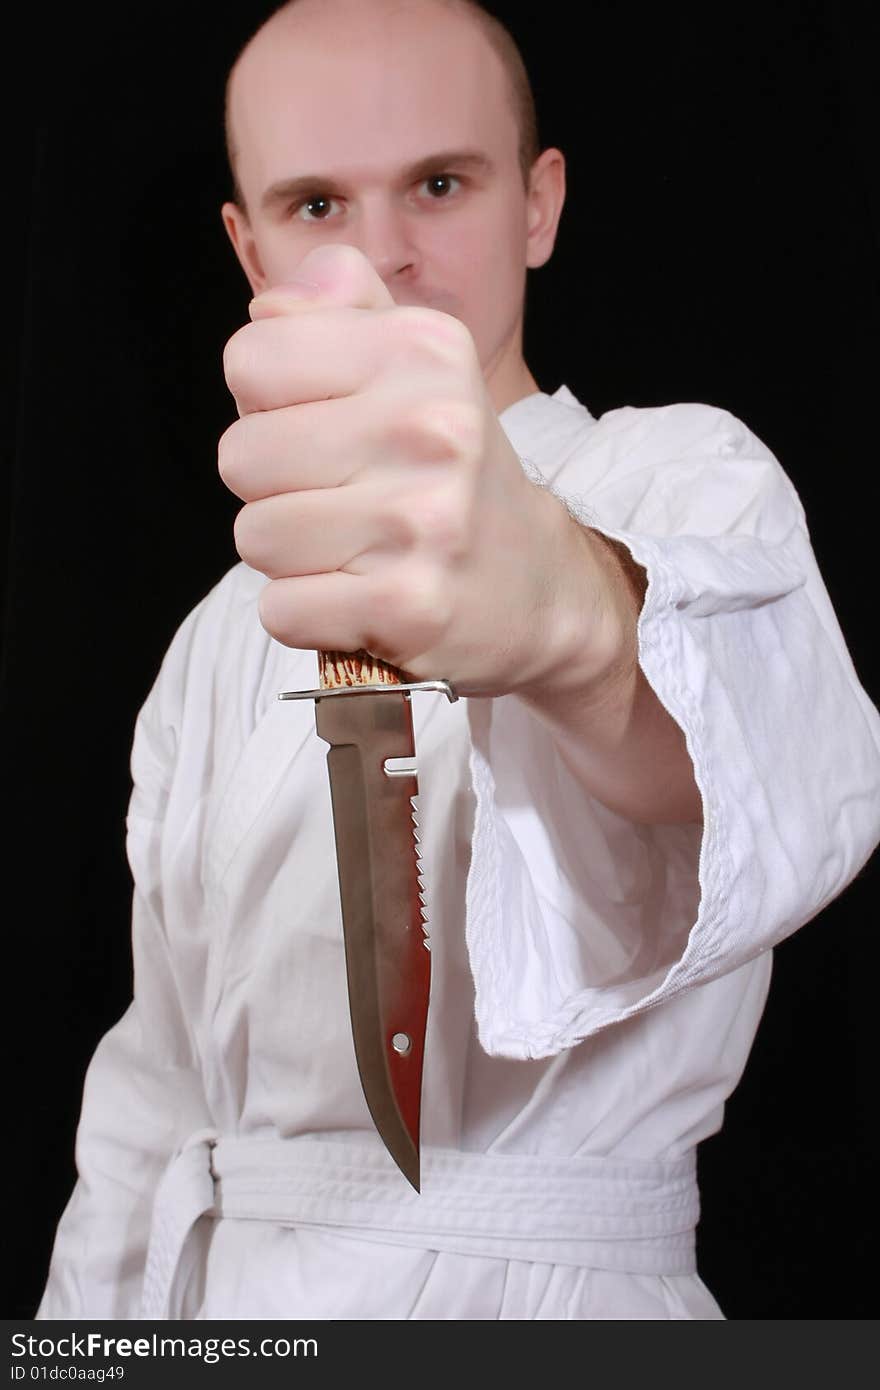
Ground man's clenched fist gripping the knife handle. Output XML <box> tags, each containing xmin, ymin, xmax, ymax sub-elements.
<box><xmin>220</xmin><ymin>246</ymin><xmax>620</xmax><ymax>695</ymax></box>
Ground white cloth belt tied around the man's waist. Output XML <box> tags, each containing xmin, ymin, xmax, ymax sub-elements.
<box><xmin>140</xmin><ymin>1131</ymin><xmax>699</xmax><ymax>1319</ymax></box>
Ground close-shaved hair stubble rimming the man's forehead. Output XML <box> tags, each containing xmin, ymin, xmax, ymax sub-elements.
<box><xmin>225</xmin><ymin>0</ymin><xmax>541</xmax><ymax>211</ymax></box>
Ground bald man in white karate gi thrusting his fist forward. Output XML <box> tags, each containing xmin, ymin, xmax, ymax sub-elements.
<box><xmin>40</xmin><ymin>0</ymin><xmax>880</xmax><ymax>1318</ymax></box>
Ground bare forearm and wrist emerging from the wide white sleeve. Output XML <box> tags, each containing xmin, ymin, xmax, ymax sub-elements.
<box><xmin>517</xmin><ymin>516</ymin><xmax>702</xmax><ymax>824</ymax></box>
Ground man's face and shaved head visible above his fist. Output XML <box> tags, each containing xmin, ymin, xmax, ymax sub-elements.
<box><xmin>224</xmin><ymin>0</ymin><xmax>558</xmax><ymax>389</ymax></box>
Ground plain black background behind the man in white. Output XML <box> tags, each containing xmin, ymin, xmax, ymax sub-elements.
<box><xmin>1</xmin><ymin>0</ymin><xmax>879</xmax><ymax>1319</ymax></box>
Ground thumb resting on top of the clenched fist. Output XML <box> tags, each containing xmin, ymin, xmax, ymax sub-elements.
<box><xmin>250</xmin><ymin>245</ymin><xmax>393</xmax><ymax>320</ymax></box>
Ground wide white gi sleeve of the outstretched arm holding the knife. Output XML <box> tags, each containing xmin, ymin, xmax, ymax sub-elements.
<box><xmin>467</xmin><ymin>406</ymin><xmax>880</xmax><ymax>1058</ymax></box>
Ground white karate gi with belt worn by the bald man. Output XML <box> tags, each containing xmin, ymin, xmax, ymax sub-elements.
<box><xmin>39</xmin><ymin>386</ymin><xmax>880</xmax><ymax>1319</ymax></box>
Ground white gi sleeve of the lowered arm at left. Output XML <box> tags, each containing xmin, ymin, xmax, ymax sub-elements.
<box><xmin>36</xmin><ymin>608</ymin><xmax>209</xmax><ymax>1319</ymax></box>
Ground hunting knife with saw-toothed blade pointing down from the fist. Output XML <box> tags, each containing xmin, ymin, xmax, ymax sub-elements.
<box><xmin>278</xmin><ymin>651</ymin><xmax>457</xmax><ymax>1191</ymax></box>
